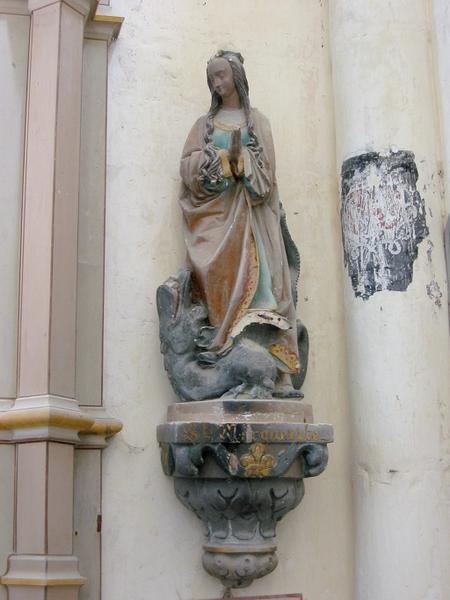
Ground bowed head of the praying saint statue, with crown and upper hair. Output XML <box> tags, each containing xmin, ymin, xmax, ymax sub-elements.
<box><xmin>206</xmin><ymin>50</ymin><xmax>249</xmax><ymax>109</ymax></box>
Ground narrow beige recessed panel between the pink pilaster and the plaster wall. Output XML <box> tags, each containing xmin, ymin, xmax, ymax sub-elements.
<box><xmin>76</xmin><ymin>39</ymin><xmax>108</xmax><ymax>406</ymax></box>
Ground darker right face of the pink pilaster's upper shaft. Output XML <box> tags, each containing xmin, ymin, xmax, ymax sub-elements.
<box><xmin>50</xmin><ymin>4</ymin><xmax>84</xmax><ymax>398</ymax></box>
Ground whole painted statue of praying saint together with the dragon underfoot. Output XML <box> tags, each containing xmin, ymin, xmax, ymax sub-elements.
<box><xmin>158</xmin><ymin>51</ymin><xmax>307</xmax><ymax>400</ymax></box>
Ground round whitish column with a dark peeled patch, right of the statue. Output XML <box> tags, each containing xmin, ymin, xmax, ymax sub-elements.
<box><xmin>330</xmin><ymin>0</ymin><xmax>450</xmax><ymax>600</ymax></box>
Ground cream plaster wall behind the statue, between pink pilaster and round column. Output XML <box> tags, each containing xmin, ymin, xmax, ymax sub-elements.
<box><xmin>102</xmin><ymin>0</ymin><xmax>353</xmax><ymax>600</ymax></box>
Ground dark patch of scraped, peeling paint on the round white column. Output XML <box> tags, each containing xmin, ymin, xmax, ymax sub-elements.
<box><xmin>341</xmin><ymin>151</ymin><xmax>428</xmax><ymax>300</ymax></box>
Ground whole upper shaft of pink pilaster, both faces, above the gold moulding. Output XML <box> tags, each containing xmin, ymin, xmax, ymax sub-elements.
<box><xmin>19</xmin><ymin>3</ymin><xmax>84</xmax><ymax>397</ymax></box>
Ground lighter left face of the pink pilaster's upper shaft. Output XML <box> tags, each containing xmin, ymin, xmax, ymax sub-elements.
<box><xmin>19</xmin><ymin>4</ymin><xmax>60</xmax><ymax>396</ymax></box>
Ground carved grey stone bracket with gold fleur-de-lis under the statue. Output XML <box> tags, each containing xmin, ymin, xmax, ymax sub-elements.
<box><xmin>158</xmin><ymin>399</ymin><xmax>333</xmax><ymax>588</ymax></box>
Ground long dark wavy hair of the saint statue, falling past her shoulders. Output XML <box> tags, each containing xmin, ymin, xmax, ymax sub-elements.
<box><xmin>200</xmin><ymin>50</ymin><xmax>263</xmax><ymax>183</ymax></box>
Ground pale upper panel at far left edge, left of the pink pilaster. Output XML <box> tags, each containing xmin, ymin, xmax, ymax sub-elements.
<box><xmin>0</xmin><ymin>14</ymin><xmax>30</xmax><ymax>402</ymax></box>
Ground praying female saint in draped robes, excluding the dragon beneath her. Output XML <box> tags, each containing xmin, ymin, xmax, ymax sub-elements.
<box><xmin>180</xmin><ymin>51</ymin><xmax>301</xmax><ymax>397</ymax></box>
